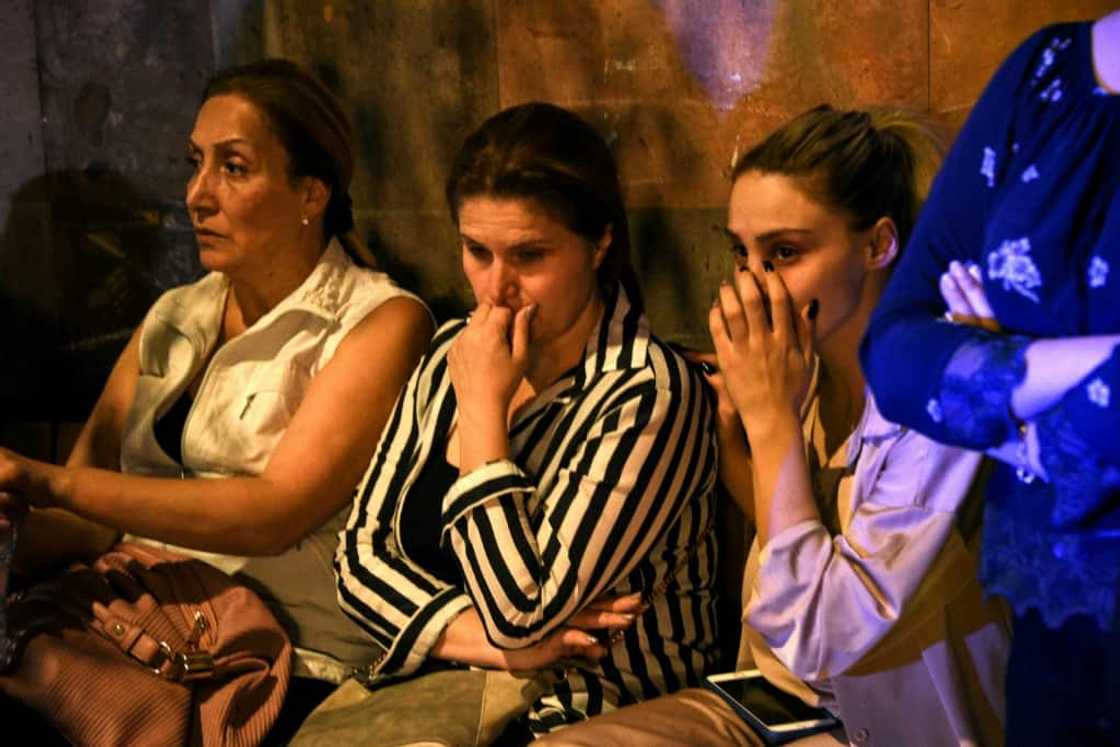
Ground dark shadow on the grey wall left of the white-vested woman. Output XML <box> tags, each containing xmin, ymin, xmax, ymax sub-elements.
<box><xmin>0</xmin><ymin>171</ymin><xmax>202</xmax><ymax>420</ymax></box>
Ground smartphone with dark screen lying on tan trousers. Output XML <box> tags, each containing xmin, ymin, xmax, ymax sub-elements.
<box><xmin>704</xmin><ymin>670</ymin><xmax>840</xmax><ymax>745</ymax></box>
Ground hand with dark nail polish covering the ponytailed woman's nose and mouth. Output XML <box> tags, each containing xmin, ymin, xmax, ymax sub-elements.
<box><xmin>708</xmin><ymin>268</ymin><xmax>815</xmax><ymax>440</ymax></box>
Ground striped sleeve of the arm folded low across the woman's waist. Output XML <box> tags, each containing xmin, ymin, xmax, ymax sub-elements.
<box><xmin>335</xmin><ymin>323</ymin><xmax>470</xmax><ymax>675</ymax></box>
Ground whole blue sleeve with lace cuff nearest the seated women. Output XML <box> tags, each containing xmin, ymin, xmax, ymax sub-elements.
<box><xmin>860</xmin><ymin>31</ymin><xmax>1047</xmax><ymax>449</ymax></box>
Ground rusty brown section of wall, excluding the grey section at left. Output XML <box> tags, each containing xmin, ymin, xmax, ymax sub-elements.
<box><xmin>243</xmin><ymin>0</ymin><xmax>1111</xmax><ymax>344</ymax></box>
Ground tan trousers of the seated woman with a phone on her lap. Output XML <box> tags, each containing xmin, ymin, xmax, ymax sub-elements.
<box><xmin>533</xmin><ymin>688</ymin><xmax>848</xmax><ymax>747</ymax></box>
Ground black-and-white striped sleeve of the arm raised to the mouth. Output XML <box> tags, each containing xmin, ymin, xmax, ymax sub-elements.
<box><xmin>444</xmin><ymin>346</ymin><xmax>716</xmax><ymax>648</ymax></box>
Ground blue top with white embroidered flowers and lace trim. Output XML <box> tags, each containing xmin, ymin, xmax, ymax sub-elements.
<box><xmin>861</xmin><ymin>24</ymin><xmax>1120</xmax><ymax>629</ymax></box>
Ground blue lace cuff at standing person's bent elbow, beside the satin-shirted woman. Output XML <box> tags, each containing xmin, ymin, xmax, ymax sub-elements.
<box><xmin>936</xmin><ymin>334</ymin><xmax>1032</xmax><ymax>446</ymax></box>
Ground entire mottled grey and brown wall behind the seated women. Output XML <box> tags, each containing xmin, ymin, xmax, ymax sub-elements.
<box><xmin>0</xmin><ymin>0</ymin><xmax>1114</xmax><ymax>439</ymax></box>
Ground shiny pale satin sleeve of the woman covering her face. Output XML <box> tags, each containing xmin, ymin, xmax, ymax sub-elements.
<box><xmin>746</xmin><ymin>431</ymin><xmax>981</xmax><ymax>682</ymax></box>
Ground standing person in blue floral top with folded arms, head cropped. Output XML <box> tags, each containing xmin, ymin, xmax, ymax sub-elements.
<box><xmin>861</xmin><ymin>12</ymin><xmax>1120</xmax><ymax>745</ymax></box>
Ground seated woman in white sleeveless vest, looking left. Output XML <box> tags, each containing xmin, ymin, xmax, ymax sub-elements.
<box><xmin>0</xmin><ymin>60</ymin><xmax>432</xmax><ymax>734</ymax></box>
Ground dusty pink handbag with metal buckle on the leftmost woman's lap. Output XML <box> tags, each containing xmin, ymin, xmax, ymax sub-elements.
<box><xmin>0</xmin><ymin>543</ymin><xmax>291</xmax><ymax>747</ymax></box>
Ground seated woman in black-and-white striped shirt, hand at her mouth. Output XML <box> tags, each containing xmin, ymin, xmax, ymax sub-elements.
<box><xmin>336</xmin><ymin>103</ymin><xmax>717</xmax><ymax>734</ymax></box>
